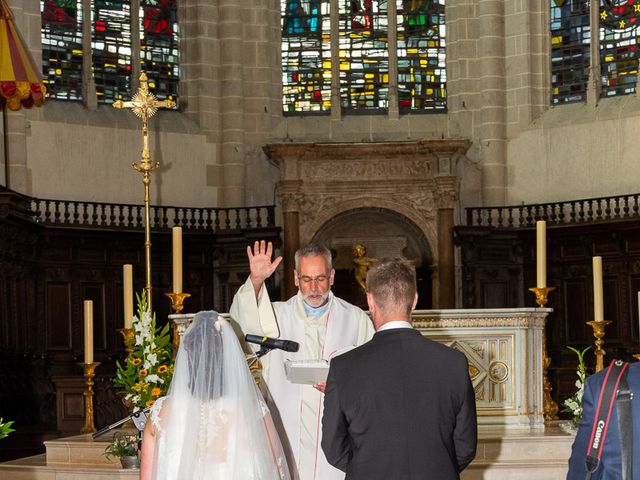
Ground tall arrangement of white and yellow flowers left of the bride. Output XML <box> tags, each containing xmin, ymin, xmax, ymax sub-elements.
<box><xmin>113</xmin><ymin>290</ymin><xmax>173</xmax><ymax>412</ymax></box>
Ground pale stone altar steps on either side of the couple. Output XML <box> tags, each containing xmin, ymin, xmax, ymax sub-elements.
<box><xmin>0</xmin><ymin>424</ymin><xmax>573</xmax><ymax>480</ymax></box>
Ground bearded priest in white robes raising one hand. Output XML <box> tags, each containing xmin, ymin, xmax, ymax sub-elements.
<box><xmin>230</xmin><ymin>240</ymin><xmax>374</xmax><ymax>480</ymax></box>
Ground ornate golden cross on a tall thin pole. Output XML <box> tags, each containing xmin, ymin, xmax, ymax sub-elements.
<box><xmin>113</xmin><ymin>72</ymin><xmax>176</xmax><ymax>312</ymax></box>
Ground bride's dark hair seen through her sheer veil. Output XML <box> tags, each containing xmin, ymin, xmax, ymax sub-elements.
<box><xmin>181</xmin><ymin>315</ymin><xmax>224</xmax><ymax>400</ymax></box>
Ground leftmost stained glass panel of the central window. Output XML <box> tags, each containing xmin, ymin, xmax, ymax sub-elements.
<box><xmin>281</xmin><ymin>0</ymin><xmax>331</xmax><ymax>113</ymax></box>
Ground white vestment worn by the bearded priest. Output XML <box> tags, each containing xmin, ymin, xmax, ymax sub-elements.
<box><xmin>230</xmin><ymin>279</ymin><xmax>374</xmax><ymax>480</ymax></box>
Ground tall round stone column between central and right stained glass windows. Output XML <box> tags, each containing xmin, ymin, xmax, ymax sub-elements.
<box><xmin>478</xmin><ymin>0</ymin><xmax>507</xmax><ymax>205</ymax></box>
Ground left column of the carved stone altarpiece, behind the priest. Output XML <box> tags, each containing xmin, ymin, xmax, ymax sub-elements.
<box><xmin>278</xmin><ymin>185</ymin><xmax>300</xmax><ymax>299</ymax></box>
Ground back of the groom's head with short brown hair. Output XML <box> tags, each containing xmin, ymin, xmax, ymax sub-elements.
<box><xmin>367</xmin><ymin>257</ymin><xmax>417</xmax><ymax>315</ymax></box>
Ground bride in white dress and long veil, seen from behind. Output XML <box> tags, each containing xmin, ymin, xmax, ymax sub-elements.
<box><xmin>140</xmin><ymin>311</ymin><xmax>289</xmax><ymax>480</ymax></box>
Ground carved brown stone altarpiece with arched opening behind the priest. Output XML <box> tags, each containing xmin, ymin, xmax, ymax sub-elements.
<box><xmin>264</xmin><ymin>140</ymin><xmax>471</xmax><ymax>308</ymax></box>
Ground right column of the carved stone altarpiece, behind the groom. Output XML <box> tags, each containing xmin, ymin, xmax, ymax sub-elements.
<box><xmin>434</xmin><ymin>176</ymin><xmax>457</xmax><ymax>309</ymax></box>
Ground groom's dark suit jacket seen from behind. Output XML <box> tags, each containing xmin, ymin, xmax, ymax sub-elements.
<box><xmin>322</xmin><ymin>328</ymin><xmax>477</xmax><ymax>480</ymax></box>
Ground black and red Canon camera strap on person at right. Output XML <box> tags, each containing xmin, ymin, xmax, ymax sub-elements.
<box><xmin>586</xmin><ymin>360</ymin><xmax>633</xmax><ymax>480</ymax></box>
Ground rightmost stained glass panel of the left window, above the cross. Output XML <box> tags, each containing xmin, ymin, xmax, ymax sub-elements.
<box><xmin>140</xmin><ymin>0</ymin><xmax>180</xmax><ymax>100</ymax></box>
